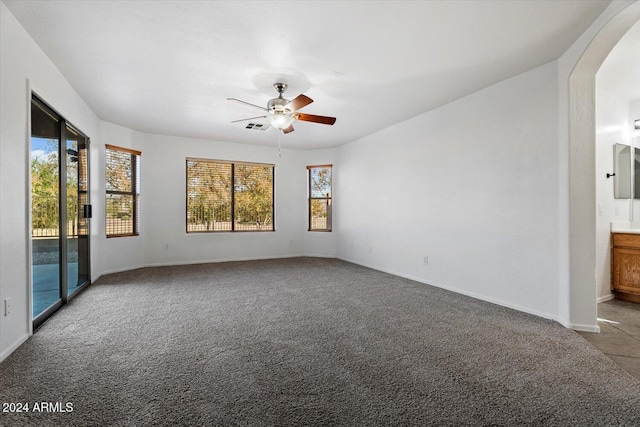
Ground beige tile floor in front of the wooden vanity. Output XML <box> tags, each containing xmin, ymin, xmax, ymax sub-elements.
<box><xmin>579</xmin><ymin>299</ymin><xmax>640</xmax><ymax>380</ymax></box>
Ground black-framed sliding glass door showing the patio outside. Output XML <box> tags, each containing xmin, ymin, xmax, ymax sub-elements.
<box><xmin>31</xmin><ymin>97</ymin><xmax>91</xmax><ymax>328</ymax></box>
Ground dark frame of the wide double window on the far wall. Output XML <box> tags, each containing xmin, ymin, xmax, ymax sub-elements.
<box><xmin>185</xmin><ymin>157</ymin><xmax>276</xmax><ymax>234</ymax></box>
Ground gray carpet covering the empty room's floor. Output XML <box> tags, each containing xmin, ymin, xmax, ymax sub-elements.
<box><xmin>0</xmin><ymin>258</ymin><xmax>640</xmax><ymax>426</ymax></box>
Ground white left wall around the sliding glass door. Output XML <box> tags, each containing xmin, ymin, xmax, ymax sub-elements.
<box><xmin>0</xmin><ymin>2</ymin><xmax>99</xmax><ymax>360</ymax></box>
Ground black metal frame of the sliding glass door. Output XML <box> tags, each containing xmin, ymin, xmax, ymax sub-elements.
<box><xmin>29</xmin><ymin>92</ymin><xmax>91</xmax><ymax>331</ymax></box>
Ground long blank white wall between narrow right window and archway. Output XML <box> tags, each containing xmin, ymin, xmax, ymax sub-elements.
<box><xmin>335</xmin><ymin>63</ymin><xmax>559</xmax><ymax>318</ymax></box>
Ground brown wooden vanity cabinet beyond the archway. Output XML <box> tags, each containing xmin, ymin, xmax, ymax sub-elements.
<box><xmin>611</xmin><ymin>233</ymin><xmax>640</xmax><ymax>302</ymax></box>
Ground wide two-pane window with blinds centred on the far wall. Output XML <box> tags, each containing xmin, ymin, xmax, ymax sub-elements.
<box><xmin>187</xmin><ymin>158</ymin><xmax>274</xmax><ymax>233</ymax></box>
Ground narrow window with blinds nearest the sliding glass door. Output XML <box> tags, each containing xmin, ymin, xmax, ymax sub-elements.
<box><xmin>105</xmin><ymin>144</ymin><xmax>142</xmax><ymax>237</ymax></box>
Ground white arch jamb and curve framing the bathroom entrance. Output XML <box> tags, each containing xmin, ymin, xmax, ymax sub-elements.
<box><xmin>560</xmin><ymin>2</ymin><xmax>640</xmax><ymax>330</ymax></box>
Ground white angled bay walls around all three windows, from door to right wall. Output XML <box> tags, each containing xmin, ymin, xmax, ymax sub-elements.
<box><xmin>93</xmin><ymin>122</ymin><xmax>337</xmax><ymax>279</ymax></box>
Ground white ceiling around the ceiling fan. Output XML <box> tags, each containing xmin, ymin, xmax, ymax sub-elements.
<box><xmin>2</xmin><ymin>0</ymin><xmax>609</xmax><ymax>148</ymax></box>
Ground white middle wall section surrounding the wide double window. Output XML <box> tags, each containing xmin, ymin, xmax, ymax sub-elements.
<box><xmin>141</xmin><ymin>135</ymin><xmax>318</xmax><ymax>265</ymax></box>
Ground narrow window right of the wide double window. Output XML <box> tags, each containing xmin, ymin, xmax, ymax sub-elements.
<box><xmin>307</xmin><ymin>165</ymin><xmax>332</xmax><ymax>231</ymax></box>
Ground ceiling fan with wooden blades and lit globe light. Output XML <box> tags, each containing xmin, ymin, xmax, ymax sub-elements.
<box><xmin>227</xmin><ymin>83</ymin><xmax>336</xmax><ymax>133</ymax></box>
